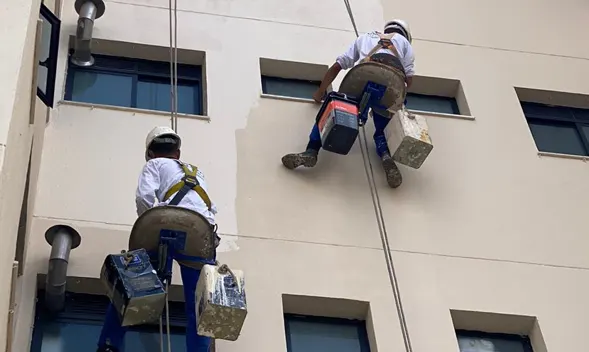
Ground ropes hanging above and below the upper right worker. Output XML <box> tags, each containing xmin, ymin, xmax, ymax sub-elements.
<box><xmin>344</xmin><ymin>0</ymin><xmax>413</xmax><ymax>352</ymax></box>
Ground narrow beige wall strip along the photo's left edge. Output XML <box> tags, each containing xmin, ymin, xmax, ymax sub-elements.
<box><xmin>0</xmin><ymin>0</ymin><xmax>40</xmax><ymax>348</ymax></box>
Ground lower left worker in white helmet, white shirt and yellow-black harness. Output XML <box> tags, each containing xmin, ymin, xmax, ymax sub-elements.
<box><xmin>98</xmin><ymin>127</ymin><xmax>219</xmax><ymax>352</ymax></box>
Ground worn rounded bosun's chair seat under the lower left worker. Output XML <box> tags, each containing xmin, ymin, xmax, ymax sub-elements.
<box><xmin>129</xmin><ymin>206</ymin><xmax>218</xmax><ymax>269</ymax></box>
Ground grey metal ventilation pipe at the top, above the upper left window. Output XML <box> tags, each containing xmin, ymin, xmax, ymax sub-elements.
<box><xmin>71</xmin><ymin>0</ymin><xmax>106</xmax><ymax>67</ymax></box>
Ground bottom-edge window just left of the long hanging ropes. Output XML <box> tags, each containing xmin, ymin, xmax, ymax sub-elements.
<box><xmin>284</xmin><ymin>314</ymin><xmax>370</xmax><ymax>352</ymax></box>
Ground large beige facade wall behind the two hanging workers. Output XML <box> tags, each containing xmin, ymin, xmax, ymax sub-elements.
<box><xmin>8</xmin><ymin>0</ymin><xmax>589</xmax><ymax>352</ymax></box>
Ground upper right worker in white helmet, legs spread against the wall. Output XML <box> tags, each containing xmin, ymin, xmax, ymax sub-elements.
<box><xmin>282</xmin><ymin>20</ymin><xmax>415</xmax><ymax>188</ymax></box>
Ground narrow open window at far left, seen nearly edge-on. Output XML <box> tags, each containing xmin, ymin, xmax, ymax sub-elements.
<box><xmin>37</xmin><ymin>4</ymin><xmax>61</xmax><ymax>108</ymax></box>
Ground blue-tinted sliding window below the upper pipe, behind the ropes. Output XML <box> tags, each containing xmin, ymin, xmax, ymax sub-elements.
<box><xmin>65</xmin><ymin>55</ymin><xmax>203</xmax><ymax>115</ymax></box>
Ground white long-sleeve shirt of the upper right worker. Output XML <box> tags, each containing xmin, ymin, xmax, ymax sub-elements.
<box><xmin>336</xmin><ymin>32</ymin><xmax>415</xmax><ymax>77</ymax></box>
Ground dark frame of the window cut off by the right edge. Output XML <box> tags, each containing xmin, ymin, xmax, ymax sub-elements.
<box><xmin>520</xmin><ymin>101</ymin><xmax>589</xmax><ymax>157</ymax></box>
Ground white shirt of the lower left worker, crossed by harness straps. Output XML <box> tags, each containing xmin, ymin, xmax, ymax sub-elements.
<box><xmin>135</xmin><ymin>158</ymin><xmax>217</xmax><ymax>225</ymax></box>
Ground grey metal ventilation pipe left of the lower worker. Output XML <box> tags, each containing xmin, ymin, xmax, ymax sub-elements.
<box><xmin>45</xmin><ymin>225</ymin><xmax>82</xmax><ymax>312</ymax></box>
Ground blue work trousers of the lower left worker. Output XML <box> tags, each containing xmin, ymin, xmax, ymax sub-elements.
<box><xmin>98</xmin><ymin>265</ymin><xmax>211</xmax><ymax>352</ymax></box>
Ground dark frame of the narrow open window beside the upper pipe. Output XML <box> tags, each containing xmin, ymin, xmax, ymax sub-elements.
<box><xmin>35</xmin><ymin>3</ymin><xmax>61</xmax><ymax>108</ymax></box>
